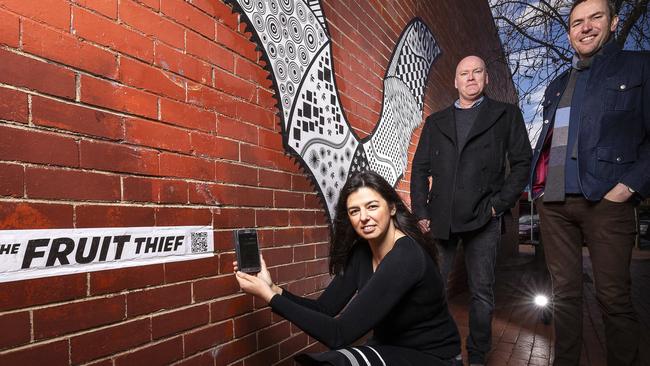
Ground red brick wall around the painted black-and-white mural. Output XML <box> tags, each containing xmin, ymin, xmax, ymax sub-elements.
<box><xmin>0</xmin><ymin>0</ymin><xmax>514</xmax><ymax>366</ymax></box>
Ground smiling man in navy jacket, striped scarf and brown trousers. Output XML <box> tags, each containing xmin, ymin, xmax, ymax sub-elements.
<box><xmin>530</xmin><ymin>0</ymin><xmax>650</xmax><ymax>365</ymax></box>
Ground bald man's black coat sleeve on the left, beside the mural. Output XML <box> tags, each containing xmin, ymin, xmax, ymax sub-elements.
<box><xmin>411</xmin><ymin>121</ymin><xmax>431</xmax><ymax>219</ymax></box>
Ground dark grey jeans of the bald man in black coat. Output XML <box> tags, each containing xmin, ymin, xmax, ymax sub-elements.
<box><xmin>437</xmin><ymin>217</ymin><xmax>501</xmax><ymax>363</ymax></box>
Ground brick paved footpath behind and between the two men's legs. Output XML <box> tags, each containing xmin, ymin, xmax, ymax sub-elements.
<box><xmin>449</xmin><ymin>246</ymin><xmax>650</xmax><ymax>366</ymax></box>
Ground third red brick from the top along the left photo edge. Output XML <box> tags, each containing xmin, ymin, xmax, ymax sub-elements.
<box><xmin>0</xmin><ymin>49</ymin><xmax>75</xmax><ymax>99</ymax></box>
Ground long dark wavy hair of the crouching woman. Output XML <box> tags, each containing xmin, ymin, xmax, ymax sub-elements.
<box><xmin>329</xmin><ymin>171</ymin><xmax>438</xmax><ymax>275</ymax></box>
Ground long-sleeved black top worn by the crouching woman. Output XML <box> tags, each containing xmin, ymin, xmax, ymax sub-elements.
<box><xmin>270</xmin><ymin>237</ymin><xmax>460</xmax><ymax>362</ymax></box>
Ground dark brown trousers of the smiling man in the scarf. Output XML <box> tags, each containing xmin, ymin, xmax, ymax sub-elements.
<box><xmin>537</xmin><ymin>195</ymin><xmax>639</xmax><ymax>366</ymax></box>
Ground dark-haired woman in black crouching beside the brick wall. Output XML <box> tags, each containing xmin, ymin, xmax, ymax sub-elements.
<box><xmin>234</xmin><ymin>171</ymin><xmax>462</xmax><ymax>366</ymax></box>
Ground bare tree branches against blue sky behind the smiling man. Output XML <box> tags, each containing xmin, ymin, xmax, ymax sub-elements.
<box><xmin>490</xmin><ymin>0</ymin><xmax>650</xmax><ymax>140</ymax></box>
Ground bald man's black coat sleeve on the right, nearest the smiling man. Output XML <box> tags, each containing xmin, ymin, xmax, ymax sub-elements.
<box><xmin>491</xmin><ymin>106</ymin><xmax>532</xmax><ymax>214</ymax></box>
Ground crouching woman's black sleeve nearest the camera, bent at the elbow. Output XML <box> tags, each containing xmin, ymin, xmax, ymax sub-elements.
<box><xmin>270</xmin><ymin>239</ymin><xmax>425</xmax><ymax>348</ymax></box>
